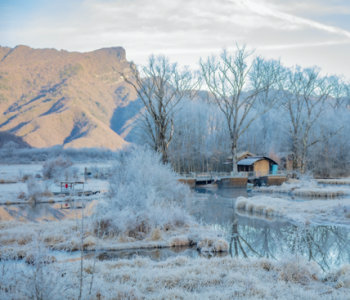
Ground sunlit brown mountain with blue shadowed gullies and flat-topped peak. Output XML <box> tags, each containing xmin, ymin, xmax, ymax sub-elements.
<box><xmin>0</xmin><ymin>46</ymin><xmax>139</xmax><ymax>149</ymax></box>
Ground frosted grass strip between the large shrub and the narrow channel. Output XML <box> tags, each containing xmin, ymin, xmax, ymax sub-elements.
<box><xmin>0</xmin><ymin>218</ymin><xmax>228</xmax><ymax>257</ymax></box>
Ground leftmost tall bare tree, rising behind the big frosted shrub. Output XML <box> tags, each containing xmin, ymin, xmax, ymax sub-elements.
<box><xmin>120</xmin><ymin>55</ymin><xmax>200</xmax><ymax>163</ymax></box>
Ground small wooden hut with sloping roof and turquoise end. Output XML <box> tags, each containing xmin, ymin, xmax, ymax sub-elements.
<box><xmin>237</xmin><ymin>156</ymin><xmax>278</xmax><ymax>176</ymax></box>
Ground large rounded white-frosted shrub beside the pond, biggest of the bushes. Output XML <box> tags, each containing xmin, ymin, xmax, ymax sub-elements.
<box><xmin>96</xmin><ymin>148</ymin><xmax>194</xmax><ymax>236</ymax></box>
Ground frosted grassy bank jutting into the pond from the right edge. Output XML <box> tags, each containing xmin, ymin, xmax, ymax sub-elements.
<box><xmin>236</xmin><ymin>196</ymin><xmax>350</xmax><ymax>226</ymax></box>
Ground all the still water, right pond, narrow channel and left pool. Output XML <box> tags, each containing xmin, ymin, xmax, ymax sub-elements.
<box><xmin>0</xmin><ymin>188</ymin><xmax>350</xmax><ymax>271</ymax></box>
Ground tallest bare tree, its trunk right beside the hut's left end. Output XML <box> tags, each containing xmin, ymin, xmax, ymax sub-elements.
<box><xmin>200</xmin><ymin>46</ymin><xmax>283</xmax><ymax>175</ymax></box>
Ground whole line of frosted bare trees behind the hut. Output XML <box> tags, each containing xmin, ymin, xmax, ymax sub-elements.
<box><xmin>121</xmin><ymin>46</ymin><xmax>350</xmax><ymax>176</ymax></box>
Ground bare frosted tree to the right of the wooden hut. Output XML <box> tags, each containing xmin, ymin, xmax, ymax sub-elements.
<box><xmin>283</xmin><ymin>66</ymin><xmax>340</xmax><ymax>174</ymax></box>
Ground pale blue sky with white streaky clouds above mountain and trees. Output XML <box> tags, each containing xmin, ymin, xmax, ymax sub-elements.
<box><xmin>0</xmin><ymin>0</ymin><xmax>350</xmax><ymax>79</ymax></box>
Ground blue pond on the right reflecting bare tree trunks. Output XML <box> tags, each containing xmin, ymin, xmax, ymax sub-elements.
<box><xmin>197</xmin><ymin>189</ymin><xmax>350</xmax><ymax>271</ymax></box>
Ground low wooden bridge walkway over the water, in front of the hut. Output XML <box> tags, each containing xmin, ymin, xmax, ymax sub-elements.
<box><xmin>179</xmin><ymin>171</ymin><xmax>287</xmax><ymax>187</ymax></box>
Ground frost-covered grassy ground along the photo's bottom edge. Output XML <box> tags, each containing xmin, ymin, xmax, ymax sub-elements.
<box><xmin>0</xmin><ymin>256</ymin><xmax>350</xmax><ymax>300</ymax></box>
